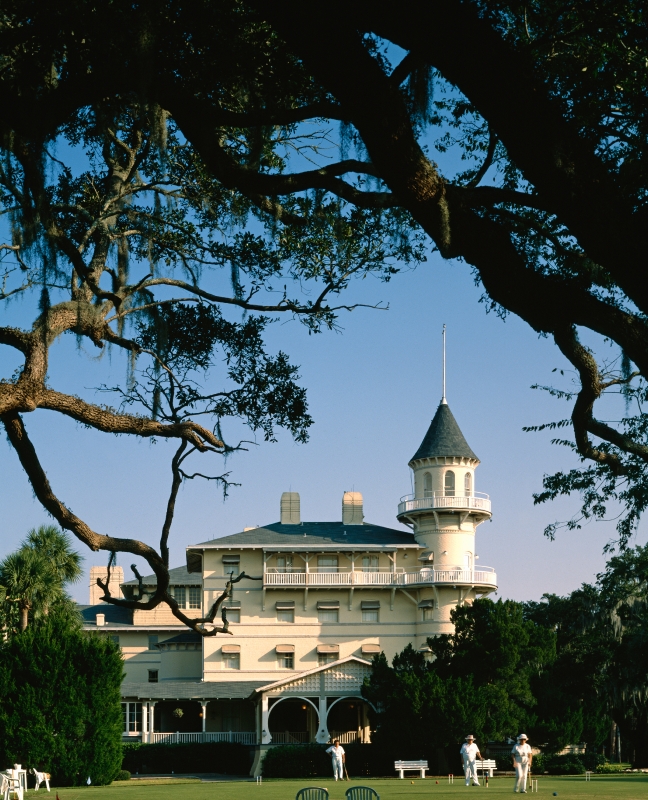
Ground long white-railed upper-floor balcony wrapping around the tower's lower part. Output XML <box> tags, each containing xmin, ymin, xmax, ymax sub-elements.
<box><xmin>263</xmin><ymin>566</ymin><xmax>497</xmax><ymax>589</ymax></box>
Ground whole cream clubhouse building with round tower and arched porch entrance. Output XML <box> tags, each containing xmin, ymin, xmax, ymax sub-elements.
<box><xmin>82</xmin><ymin>399</ymin><xmax>497</xmax><ymax>771</ymax></box>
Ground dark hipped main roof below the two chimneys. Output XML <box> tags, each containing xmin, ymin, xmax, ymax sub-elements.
<box><xmin>191</xmin><ymin>522</ymin><xmax>416</xmax><ymax>548</ymax></box>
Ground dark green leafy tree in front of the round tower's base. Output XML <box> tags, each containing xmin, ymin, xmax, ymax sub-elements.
<box><xmin>363</xmin><ymin>600</ymin><xmax>555</xmax><ymax>758</ymax></box>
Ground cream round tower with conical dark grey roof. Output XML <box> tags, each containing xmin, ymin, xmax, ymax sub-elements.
<box><xmin>397</xmin><ymin>397</ymin><xmax>497</xmax><ymax>644</ymax></box>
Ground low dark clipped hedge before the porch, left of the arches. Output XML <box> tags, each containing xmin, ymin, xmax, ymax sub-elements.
<box><xmin>122</xmin><ymin>742</ymin><xmax>251</xmax><ymax>775</ymax></box>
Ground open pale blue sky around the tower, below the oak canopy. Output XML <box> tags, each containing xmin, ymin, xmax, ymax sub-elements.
<box><xmin>0</xmin><ymin>241</ymin><xmax>645</xmax><ymax>601</ymax></box>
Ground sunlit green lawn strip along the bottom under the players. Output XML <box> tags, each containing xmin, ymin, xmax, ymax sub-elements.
<box><xmin>52</xmin><ymin>774</ymin><xmax>648</xmax><ymax>800</ymax></box>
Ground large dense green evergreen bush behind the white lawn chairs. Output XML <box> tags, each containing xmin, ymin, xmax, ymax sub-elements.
<box><xmin>0</xmin><ymin>613</ymin><xmax>123</xmax><ymax>786</ymax></box>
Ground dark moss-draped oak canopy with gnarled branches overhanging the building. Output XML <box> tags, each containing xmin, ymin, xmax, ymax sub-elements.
<box><xmin>0</xmin><ymin>0</ymin><xmax>648</xmax><ymax>632</ymax></box>
